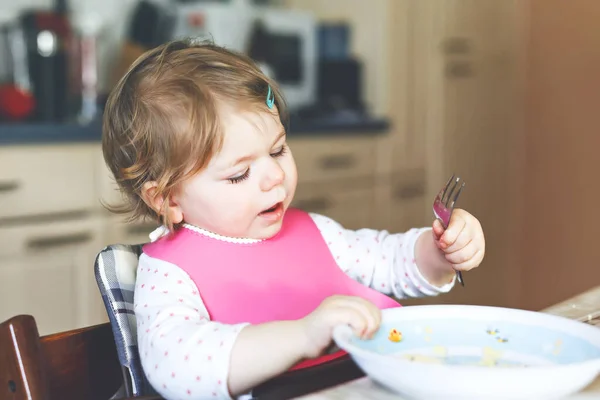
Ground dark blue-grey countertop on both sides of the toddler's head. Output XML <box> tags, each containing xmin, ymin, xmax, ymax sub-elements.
<box><xmin>0</xmin><ymin>115</ymin><xmax>390</xmax><ymax>146</ymax></box>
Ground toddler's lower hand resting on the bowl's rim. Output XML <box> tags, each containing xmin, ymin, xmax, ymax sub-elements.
<box><xmin>300</xmin><ymin>296</ymin><xmax>381</xmax><ymax>357</ymax></box>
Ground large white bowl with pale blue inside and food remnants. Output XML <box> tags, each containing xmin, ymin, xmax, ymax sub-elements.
<box><xmin>333</xmin><ymin>305</ymin><xmax>600</xmax><ymax>400</ymax></box>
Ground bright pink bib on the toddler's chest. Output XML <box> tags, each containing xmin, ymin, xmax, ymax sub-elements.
<box><xmin>144</xmin><ymin>209</ymin><xmax>400</xmax><ymax>366</ymax></box>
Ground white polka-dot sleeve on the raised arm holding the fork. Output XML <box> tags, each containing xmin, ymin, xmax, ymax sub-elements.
<box><xmin>310</xmin><ymin>214</ymin><xmax>454</xmax><ymax>298</ymax></box>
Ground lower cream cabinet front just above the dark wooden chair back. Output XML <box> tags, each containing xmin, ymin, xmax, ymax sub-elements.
<box><xmin>0</xmin><ymin>218</ymin><xmax>107</xmax><ymax>334</ymax></box>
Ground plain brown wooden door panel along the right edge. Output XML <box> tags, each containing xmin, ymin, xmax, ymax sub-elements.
<box><xmin>521</xmin><ymin>0</ymin><xmax>600</xmax><ymax>308</ymax></box>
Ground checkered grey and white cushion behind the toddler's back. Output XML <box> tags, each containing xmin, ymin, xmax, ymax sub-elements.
<box><xmin>94</xmin><ymin>244</ymin><xmax>156</xmax><ymax>396</ymax></box>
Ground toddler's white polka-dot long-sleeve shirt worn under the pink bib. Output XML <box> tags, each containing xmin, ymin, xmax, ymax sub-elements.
<box><xmin>134</xmin><ymin>214</ymin><xmax>454</xmax><ymax>399</ymax></box>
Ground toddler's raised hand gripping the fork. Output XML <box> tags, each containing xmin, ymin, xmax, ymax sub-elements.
<box><xmin>433</xmin><ymin>208</ymin><xmax>485</xmax><ymax>271</ymax></box>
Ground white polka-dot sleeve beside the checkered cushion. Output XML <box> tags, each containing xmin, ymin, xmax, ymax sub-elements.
<box><xmin>134</xmin><ymin>254</ymin><xmax>245</xmax><ymax>399</ymax></box>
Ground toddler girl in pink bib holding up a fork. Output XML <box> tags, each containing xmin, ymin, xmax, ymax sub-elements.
<box><xmin>102</xmin><ymin>41</ymin><xmax>484</xmax><ymax>399</ymax></box>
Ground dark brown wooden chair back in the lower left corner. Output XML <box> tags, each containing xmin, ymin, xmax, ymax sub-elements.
<box><xmin>0</xmin><ymin>315</ymin><xmax>125</xmax><ymax>400</ymax></box>
